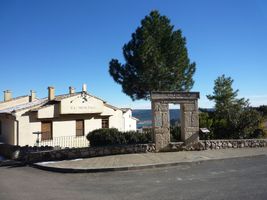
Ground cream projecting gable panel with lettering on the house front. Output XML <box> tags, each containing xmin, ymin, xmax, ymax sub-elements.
<box><xmin>60</xmin><ymin>95</ymin><xmax>104</xmax><ymax>114</ymax></box>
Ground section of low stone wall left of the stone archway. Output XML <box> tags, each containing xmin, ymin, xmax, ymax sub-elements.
<box><xmin>23</xmin><ymin>144</ymin><xmax>155</xmax><ymax>163</ymax></box>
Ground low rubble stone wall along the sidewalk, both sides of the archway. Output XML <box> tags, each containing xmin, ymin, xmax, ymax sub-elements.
<box><xmin>24</xmin><ymin>139</ymin><xmax>267</xmax><ymax>163</ymax></box>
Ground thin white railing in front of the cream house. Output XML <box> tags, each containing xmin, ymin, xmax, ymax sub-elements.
<box><xmin>38</xmin><ymin>136</ymin><xmax>89</xmax><ymax>148</ymax></box>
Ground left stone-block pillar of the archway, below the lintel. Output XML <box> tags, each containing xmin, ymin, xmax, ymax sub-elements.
<box><xmin>152</xmin><ymin>101</ymin><xmax>170</xmax><ymax>151</ymax></box>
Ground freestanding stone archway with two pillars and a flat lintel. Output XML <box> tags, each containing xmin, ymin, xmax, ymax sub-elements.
<box><xmin>151</xmin><ymin>91</ymin><xmax>199</xmax><ymax>151</ymax></box>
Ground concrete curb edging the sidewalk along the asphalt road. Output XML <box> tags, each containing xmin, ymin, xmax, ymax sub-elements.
<box><xmin>30</xmin><ymin>154</ymin><xmax>267</xmax><ymax>173</ymax></box>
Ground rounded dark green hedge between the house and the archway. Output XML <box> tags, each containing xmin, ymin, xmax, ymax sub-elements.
<box><xmin>86</xmin><ymin>128</ymin><xmax>152</xmax><ymax>146</ymax></box>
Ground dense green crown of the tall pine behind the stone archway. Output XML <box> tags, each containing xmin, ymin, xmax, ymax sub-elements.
<box><xmin>109</xmin><ymin>11</ymin><xmax>195</xmax><ymax>100</ymax></box>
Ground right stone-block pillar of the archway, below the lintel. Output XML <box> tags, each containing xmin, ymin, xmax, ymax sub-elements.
<box><xmin>181</xmin><ymin>100</ymin><xmax>199</xmax><ymax>144</ymax></box>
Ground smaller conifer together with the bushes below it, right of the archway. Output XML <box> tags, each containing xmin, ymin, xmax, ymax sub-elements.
<box><xmin>206</xmin><ymin>75</ymin><xmax>263</xmax><ymax>139</ymax></box>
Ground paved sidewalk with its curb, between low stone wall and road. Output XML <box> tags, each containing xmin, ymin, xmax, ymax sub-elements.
<box><xmin>33</xmin><ymin>148</ymin><xmax>267</xmax><ymax>173</ymax></box>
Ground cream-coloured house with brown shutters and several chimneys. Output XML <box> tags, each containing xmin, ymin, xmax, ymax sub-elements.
<box><xmin>0</xmin><ymin>85</ymin><xmax>137</xmax><ymax>147</ymax></box>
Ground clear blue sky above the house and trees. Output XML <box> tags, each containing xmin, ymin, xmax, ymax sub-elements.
<box><xmin>0</xmin><ymin>0</ymin><xmax>267</xmax><ymax>108</ymax></box>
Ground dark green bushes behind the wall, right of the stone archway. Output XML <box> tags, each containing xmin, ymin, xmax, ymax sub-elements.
<box><xmin>199</xmin><ymin>108</ymin><xmax>264</xmax><ymax>139</ymax></box>
